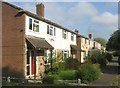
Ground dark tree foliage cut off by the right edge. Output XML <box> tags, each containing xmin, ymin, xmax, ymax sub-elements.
<box><xmin>107</xmin><ymin>29</ymin><xmax>120</xmax><ymax>50</ymax></box>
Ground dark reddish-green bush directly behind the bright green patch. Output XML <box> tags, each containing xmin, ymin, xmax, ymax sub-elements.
<box><xmin>65</xmin><ymin>57</ymin><xmax>79</xmax><ymax>69</ymax></box>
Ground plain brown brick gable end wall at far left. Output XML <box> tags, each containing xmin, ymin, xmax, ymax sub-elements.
<box><xmin>2</xmin><ymin>3</ymin><xmax>25</xmax><ymax>78</ymax></box>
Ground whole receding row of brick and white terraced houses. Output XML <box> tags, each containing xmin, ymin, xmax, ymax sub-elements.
<box><xmin>0</xmin><ymin>2</ymin><xmax>102</xmax><ymax>79</ymax></box>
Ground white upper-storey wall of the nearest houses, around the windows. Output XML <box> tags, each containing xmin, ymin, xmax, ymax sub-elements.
<box><xmin>26</xmin><ymin>16</ymin><xmax>76</xmax><ymax>59</ymax></box>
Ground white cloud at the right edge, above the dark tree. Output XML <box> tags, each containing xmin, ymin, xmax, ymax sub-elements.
<box><xmin>92</xmin><ymin>12</ymin><xmax>118</xmax><ymax>30</ymax></box>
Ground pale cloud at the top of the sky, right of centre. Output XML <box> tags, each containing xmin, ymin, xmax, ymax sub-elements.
<box><xmin>68</xmin><ymin>2</ymin><xmax>97</xmax><ymax>18</ymax></box>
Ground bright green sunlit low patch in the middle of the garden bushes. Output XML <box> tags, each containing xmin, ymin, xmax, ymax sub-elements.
<box><xmin>59</xmin><ymin>70</ymin><xmax>77</xmax><ymax>80</ymax></box>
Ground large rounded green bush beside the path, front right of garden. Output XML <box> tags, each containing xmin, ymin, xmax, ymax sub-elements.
<box><xmin>76</xmin><ymin>63</ymin><xmax>101</xmax><ymax>83</ymax></box>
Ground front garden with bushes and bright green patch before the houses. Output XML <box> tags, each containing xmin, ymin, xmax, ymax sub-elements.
<box><xmin>2</xmin><ymin>50</ymin><xmax>112</xmax><ymax>85</ymax></box>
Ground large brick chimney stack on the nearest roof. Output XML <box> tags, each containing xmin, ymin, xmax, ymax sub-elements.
<box><xmin>36</xmin><ymin>3</ymin><xmax>45</xmax><ymax>17</ymax></box>
